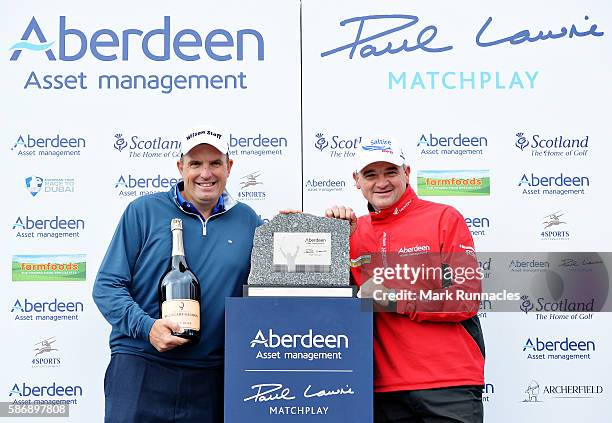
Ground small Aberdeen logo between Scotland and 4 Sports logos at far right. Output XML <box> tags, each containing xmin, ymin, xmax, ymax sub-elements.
<box><xmin>517</xmin><ymin>172</ymin><xmax>591</xmax><ymax>197</ymax></box>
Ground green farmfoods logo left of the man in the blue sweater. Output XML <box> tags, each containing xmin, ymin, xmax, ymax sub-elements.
<box><xmin>12</xmin><ymin>254</ymin><xmax>86</xmax><ymax>282</ymax></box>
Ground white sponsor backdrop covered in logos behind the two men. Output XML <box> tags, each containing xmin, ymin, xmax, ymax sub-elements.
<box><xmin>0</xmin><ymin>0</ymin><xmax>612</xmax><ymax>422</ymax></box>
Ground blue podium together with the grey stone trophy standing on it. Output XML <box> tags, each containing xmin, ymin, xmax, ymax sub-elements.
<box><xmin>224</xmin><ymin>214</ymin><xmax>373</xmax><ymax>423</ymax></box>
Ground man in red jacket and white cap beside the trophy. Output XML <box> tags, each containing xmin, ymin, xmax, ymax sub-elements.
<box><xmin>326</xmin><ymin>139</ymin><xmax>484</xmax><ymax>423</ymax></box>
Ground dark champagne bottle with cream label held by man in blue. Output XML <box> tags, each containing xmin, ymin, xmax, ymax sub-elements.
<box><xmin>157</xmin><ymin>219</ymin><xmax>200</xmax><ymax>343</ymax></box>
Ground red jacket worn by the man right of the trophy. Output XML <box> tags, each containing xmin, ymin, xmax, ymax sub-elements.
<box><xmin>350</xmin><ymin>186</ymin><xmax>484</xmax><ymax>392</ymax></box>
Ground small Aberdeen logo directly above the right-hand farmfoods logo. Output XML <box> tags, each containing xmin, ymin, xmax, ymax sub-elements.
<box><xmin>417</xmin><ymin>133</ymin><xmax>489</xmax><ymax>156</ymax></box>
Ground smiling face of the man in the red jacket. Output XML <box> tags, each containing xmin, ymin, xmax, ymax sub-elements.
<box><xmin>353</xmin><ymin>162</ymin><xmax>410</xmax><ymax>211</ymax></box>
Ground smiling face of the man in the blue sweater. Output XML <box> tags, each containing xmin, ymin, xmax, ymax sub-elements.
<box><xmin>177</xmin><ymin>144</ymin><xmax>233</xmax><ymax>218</ymax></box>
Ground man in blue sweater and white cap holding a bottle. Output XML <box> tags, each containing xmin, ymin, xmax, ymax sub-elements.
<box><xmin>93</xmin><ymin>128</ymin><xmax>262</xmax><ymax>423</ymax></box>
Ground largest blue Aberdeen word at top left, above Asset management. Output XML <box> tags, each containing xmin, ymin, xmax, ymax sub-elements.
<box><xmin>10</xmin><ymin>16</ymin><xmax>264</xmax><ymax>62</ymax></box>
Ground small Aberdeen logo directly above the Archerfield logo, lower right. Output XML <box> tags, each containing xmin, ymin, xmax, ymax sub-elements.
<box><xmin>523</xmin><ymin>337</ymin><xmax>596</xmax><ymax>361</ymax></box>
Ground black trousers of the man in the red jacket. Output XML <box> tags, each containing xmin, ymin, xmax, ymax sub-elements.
<box><xmin>374</xmin><ymin>386</ymin><xmax>483</xmax><ymax>423</ymax></box>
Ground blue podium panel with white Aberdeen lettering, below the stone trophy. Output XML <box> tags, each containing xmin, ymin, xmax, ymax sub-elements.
<box><xmin>225</xmin><ymin>298</ymin><xmax>373</xmax><ymax>423</ymax></box>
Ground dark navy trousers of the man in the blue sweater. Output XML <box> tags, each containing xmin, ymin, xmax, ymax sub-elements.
<box><xmin>104</xmin><ymin>354</ymin><xmax>223</xmax><ymax>423</ymax></box>
